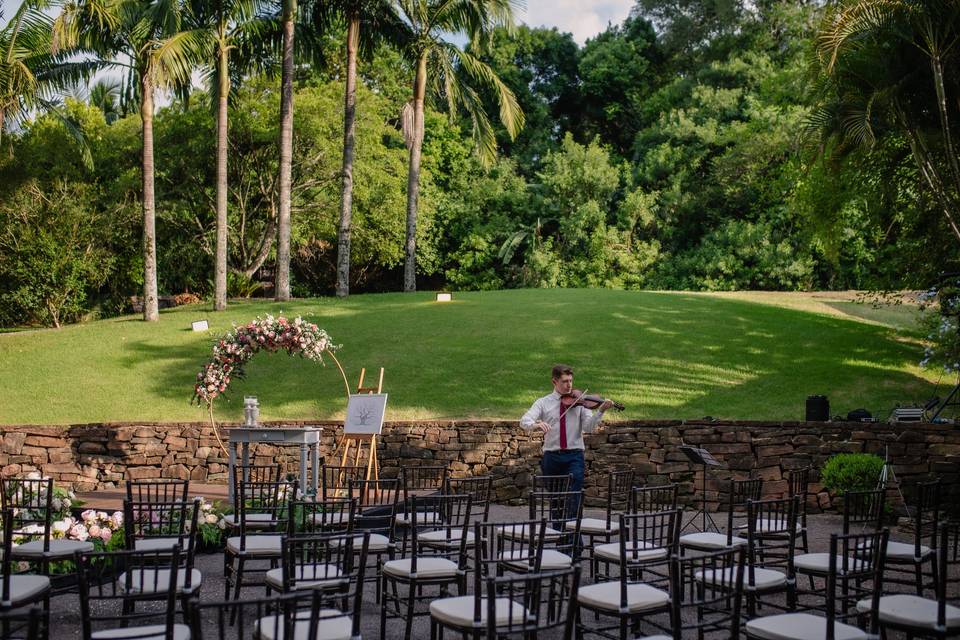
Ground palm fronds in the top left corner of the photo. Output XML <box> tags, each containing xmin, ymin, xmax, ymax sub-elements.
<box><xmin>0</xmin><ymin>0</ymin><xmax>97</xmax><ymax>149</ymax></box>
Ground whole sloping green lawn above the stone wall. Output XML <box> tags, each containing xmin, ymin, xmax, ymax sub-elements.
<box><xmin>0</xmin><ymin>289</ymin><xmax>937</xmax><ymax>424</ymax></box>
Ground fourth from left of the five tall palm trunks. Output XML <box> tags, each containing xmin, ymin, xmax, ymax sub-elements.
<box><xmin>337</xmin><ymin>15</ymin><xmax>360</xmax><ymax>297</ymax></box>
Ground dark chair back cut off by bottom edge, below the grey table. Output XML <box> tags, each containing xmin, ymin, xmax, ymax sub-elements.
<box><xmin>187</xmin><ymin>588</ymin><xmax>360</xmax><ymax>640</ymax></box>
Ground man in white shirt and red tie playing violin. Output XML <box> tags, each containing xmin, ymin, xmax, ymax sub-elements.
<box><xmin>520</xmin><ymin>364</ymin><xmax>614</xmax><ymax>500</ymax></box>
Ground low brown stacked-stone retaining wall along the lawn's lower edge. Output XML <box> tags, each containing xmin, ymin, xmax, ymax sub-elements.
<box><xmin>0</xmin><ymin>421</ymin><xmax>960</xmax><ymax>506</ymax></box>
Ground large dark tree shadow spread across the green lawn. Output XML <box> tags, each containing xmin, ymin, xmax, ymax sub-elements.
<box><xmin>116</xmin><ymin>291</ymin><xmax>933</xmax><ymax>420</ymax></box>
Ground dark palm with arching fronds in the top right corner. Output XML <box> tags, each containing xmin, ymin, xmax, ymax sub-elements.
<box><xmin>810</xmin><ymin>0</ymin><xmax>960</xmax><ymax>245</ymax></box>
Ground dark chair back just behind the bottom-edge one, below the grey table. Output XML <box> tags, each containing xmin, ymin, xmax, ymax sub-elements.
<box><xmin>282</xmin><ymin>531</ymin><xmax>370</xmax><ymax>597</ymax></box>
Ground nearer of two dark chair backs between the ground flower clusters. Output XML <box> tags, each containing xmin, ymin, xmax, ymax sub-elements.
<box><xmin>123</xmin><ymin>498</ymin><xmax>200</xmax><ymax>588</ymax></box>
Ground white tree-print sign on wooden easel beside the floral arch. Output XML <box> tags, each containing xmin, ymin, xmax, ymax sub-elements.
<box><xmin>340</xmin><ymin>367</ymin><xmax>387</xmax><ymax>480</ymax></box>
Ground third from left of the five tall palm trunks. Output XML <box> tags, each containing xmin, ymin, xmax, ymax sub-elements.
<box><xmin>274</xmin><ymin>0</ymin><xmax>297</xmax><ymax>302</ymax></box>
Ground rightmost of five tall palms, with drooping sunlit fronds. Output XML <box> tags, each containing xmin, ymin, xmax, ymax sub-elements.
<box><xmin>396</xmin><ymin>0</ymin><xmax>523</xmax><ymax>291</ymax></box>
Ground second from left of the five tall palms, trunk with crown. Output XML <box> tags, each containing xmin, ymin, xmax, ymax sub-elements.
<box><xmin>189</xmin><ymin>0</ymin><xmax>272</xmax><ymax>311</ymax></box>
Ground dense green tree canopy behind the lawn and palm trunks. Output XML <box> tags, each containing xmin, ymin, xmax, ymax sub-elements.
<box><xmin>0</xmin><ymin>0</ymin><xmax>948</xmax><ymax>325</ymax></box>
